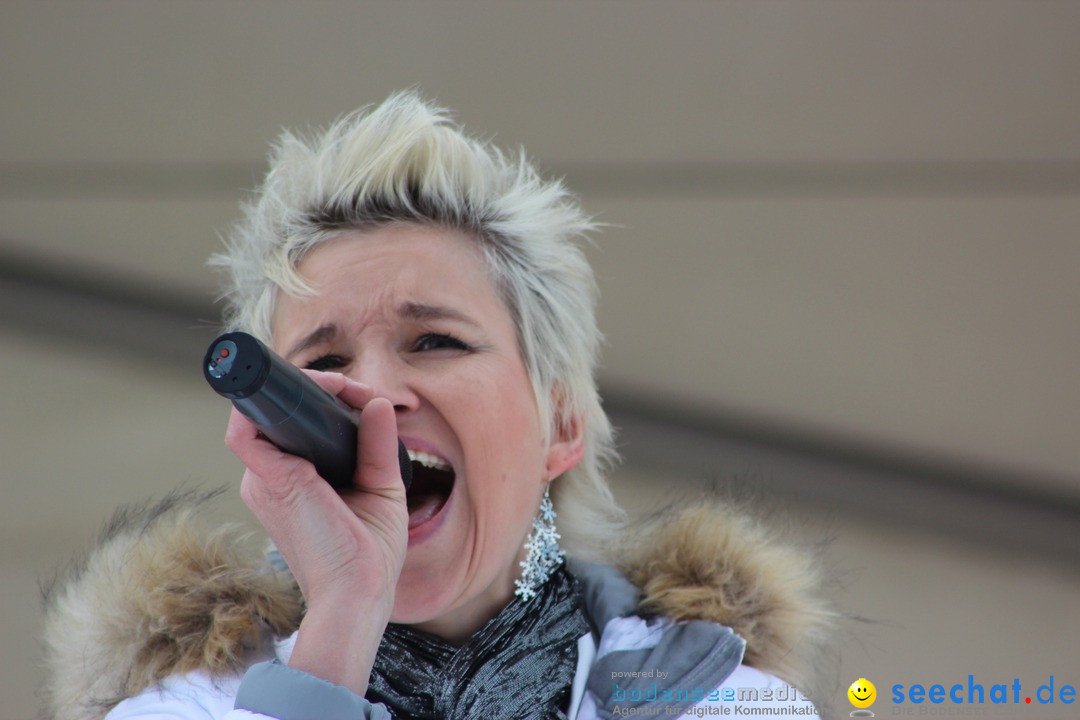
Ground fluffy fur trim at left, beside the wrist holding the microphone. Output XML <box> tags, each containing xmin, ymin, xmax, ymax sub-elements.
<box><xmin>44</xmin><ymin>493</ymin><xmax>300</xmax><ymax>720</ymax></box>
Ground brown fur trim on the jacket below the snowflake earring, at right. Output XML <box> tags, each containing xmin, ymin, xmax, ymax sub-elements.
<box><xmin>617</xmin><ymin>500</ymin><xmax>837</xmax><ymax>693</ymax></box>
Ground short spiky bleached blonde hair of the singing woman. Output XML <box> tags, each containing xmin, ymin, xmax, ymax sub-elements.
<box><xmin>211</xmin><ymin>92</ymin><xmax>623</xmax><ymax>557</ymax></box>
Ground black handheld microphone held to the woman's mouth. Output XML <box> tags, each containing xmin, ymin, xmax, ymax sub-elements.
<box><xmin>203</xmin><ymin>332</ymin><xmax>413</xmax><ymax>490</ymax></box>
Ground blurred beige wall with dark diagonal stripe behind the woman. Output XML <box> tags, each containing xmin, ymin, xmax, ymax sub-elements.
<box><xmin>0</xmin><ymin>0</ymin><xmax>1080</xmax><ymax>718</ymax></box>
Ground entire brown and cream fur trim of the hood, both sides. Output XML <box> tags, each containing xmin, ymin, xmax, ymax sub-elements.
<box><xmin>44</xmin><ymin>493</ymin><xmax>834</xmax><ymax>720</ymax></box>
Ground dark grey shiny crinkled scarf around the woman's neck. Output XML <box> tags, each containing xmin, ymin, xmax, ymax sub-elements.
<box><xmin>366</xmin><ymin>567</ymin><xmax>590</xmax><ymax>720</ymax></box>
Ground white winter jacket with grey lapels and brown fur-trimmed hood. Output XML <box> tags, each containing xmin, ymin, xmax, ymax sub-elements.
<box><xmin>45</xmin><ymin>495</ymin><xmax>831</xmax><ymax>720</ymax></box>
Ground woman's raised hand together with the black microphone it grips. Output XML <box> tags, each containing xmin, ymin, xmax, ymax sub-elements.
<box><xmin>203</xmin><ymin>332</ymin><xmax>411</xmax><ymax>694</ymax></box>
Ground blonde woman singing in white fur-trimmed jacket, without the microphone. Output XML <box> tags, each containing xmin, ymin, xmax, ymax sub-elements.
<box><xmin>48</xmin><ymin>93</ymin><xmax>828</xmax><ymax>720</ymax></box>
